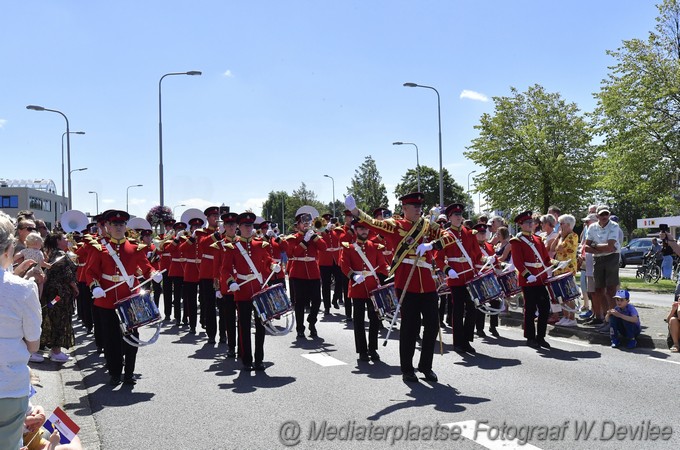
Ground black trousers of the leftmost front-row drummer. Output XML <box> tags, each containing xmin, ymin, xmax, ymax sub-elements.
<box><xmin>94</xmin><ymin>306</ymin><xmax>139</xmax><ymax>378</ymax></box>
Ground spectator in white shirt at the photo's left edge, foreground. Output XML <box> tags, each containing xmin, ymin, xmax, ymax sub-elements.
<box><xmin>0</xmin><ymin>212</ymin><xmax>41</xmax><ymax>450</ymax></box>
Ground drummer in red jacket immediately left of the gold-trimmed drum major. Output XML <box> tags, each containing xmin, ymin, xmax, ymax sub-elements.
<box><xmin>340</xmin><ymin>220</ymin><xmax>383</xmax><ymax>361</ymax></box>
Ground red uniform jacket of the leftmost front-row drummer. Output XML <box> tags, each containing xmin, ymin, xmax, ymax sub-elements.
<box><xmin>86</xmin><ymin>239</ymin><xmax>153</xmax><ymax>309</ymax></box>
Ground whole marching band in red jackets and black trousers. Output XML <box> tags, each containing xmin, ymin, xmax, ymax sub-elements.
<box><xmin>65</xmin><ymin>192</ymin><xmax>576</xmax><ymax>385</ymax></box>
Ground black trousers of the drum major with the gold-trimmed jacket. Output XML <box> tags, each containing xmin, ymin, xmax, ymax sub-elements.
<box><xmin>397</xmin><ymin>290</ymin><xmax>439</xmax><ymax>373</ymax></box>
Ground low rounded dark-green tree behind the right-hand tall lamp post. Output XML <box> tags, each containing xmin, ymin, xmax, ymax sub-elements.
<box><xmin>394</xmin><ymin>166</ymin><xmax>474</xmax><ymax>210</ymax></box>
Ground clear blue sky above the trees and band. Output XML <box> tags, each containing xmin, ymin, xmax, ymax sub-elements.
<box><xmin>0</xmin><ymin>0</ymin><xmax>657</xmax><ymax>215</ymax></box>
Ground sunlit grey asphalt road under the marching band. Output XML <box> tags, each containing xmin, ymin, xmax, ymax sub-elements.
<box><xmin>65</xmin><ymin>300</ymin><xmax>680</xmax><ymax>450</ymax></box>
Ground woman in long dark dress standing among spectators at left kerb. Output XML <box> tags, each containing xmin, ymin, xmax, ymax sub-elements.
<box><xmin>41</xmin><ymin>231</ymin><xmax>78</xmax><ymax>363</ymax></box>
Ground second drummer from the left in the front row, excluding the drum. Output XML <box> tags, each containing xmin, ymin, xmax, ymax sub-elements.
<box><xmin>222</xmin><ymin>213</ymin><xmax>281</xmax><ymax>370</ymax></box>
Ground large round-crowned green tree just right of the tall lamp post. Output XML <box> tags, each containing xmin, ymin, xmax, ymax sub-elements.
<box><xmin>465</xmin><ymin>85</ymin><xmax>595</xmax><ymax>218</ymax></box>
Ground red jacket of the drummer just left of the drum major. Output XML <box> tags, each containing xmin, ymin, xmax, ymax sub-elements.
<box><xmin>340</xmin><ymin>239</ymin><xmax>384</xmax><ymax>299</ymax></box>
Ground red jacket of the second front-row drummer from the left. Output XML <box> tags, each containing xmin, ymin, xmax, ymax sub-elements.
<box><xmin>222</xmin><ymin>236</ymin><xmax>273</xmax><ymax>302</ymax></box>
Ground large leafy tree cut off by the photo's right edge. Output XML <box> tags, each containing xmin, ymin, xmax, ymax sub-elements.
<box><xmin>594</xmin><ymin>0</ymin><xmax>680</xmax><ymax>217</ymax></box>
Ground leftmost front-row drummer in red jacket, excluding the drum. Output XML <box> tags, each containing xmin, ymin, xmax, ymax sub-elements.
<box><xmin>86</xmin><ymin>210</ymin><xmax>163</xmax><ymax>386</ymax></box>
